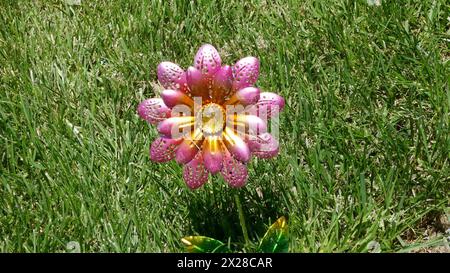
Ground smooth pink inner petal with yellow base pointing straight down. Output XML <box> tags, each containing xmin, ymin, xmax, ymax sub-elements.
<box><xmin>203</xmin><ymin>136</ymin><xmax>222</xmax><ymax>174</ymax></box>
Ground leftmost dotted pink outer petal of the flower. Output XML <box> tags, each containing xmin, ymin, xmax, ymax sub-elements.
<box><xmin>137</xmin><ymin>98</ymin><xmax>171</xmax><ymax>124</ymax></box>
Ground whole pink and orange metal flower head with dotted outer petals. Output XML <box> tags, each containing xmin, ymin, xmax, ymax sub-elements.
<box><xmin>138</xmin><ymin>44</ymin><xmax>284</xmax><ymax>189</ymax></box>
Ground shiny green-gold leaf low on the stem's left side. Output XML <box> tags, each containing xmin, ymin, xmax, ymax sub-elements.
<box><xmin>181</xmin><ymin>236</ymin><xmax>230</xmax><ymax>253</ymax></box>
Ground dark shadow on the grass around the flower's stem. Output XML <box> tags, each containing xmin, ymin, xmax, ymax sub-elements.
<box><xmin>186</xmin><ymin>177</ymin><xmax>288</xmax><ymax>249</ymax></box>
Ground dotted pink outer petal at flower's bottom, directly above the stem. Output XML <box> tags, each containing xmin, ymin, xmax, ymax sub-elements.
<box><xmin>220</xmin><ymin>149</ymin><xmax>248</xmax><ymax>188</ymax></box>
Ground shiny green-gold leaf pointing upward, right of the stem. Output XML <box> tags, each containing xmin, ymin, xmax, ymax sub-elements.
<box><xmin>258</xmin><ymin>216</ymin><xmax>289</xmax><ymax>253</ymax></box>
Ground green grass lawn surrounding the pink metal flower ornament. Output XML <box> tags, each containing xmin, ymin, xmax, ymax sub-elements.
<box><xmin>0</xmin><ymin>0</ymin><xmax>450</xmax><ymax>252</ymax></box>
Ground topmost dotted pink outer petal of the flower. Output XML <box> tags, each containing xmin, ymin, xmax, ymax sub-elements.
<box><xmin>194</xmin><ymin>44</ymin><xmax>222</xmax><ymax>77</ymax></box>
